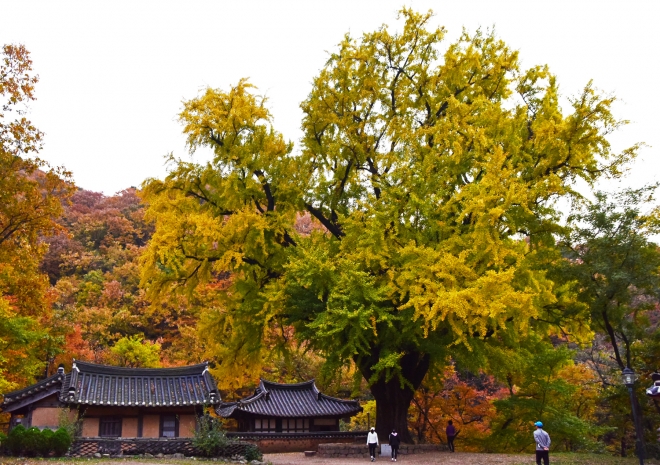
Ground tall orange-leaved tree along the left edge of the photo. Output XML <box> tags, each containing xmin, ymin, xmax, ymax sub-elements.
<box><xmin>0</xmin><ymin>45</ymin><xmax>73</xmax><ymax>390</ymax></box>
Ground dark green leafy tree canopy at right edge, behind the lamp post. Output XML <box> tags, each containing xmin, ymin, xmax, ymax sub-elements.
<box><xmin>561</xmin><ymin>186</ymin><xmax>660</xmax><ymax>370</ymax></box>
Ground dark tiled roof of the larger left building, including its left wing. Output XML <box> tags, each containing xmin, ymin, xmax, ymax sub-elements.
<box><xmin>0</xmin><ymin>361</ymin><xmax>220</xmax><ymax>410</ymax></box>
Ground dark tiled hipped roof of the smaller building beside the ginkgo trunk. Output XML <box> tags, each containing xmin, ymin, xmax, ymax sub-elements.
<box><xmin>216</xmin><ymin>380</ymin><xmax>362</xmax><ymax>418</ymax></box>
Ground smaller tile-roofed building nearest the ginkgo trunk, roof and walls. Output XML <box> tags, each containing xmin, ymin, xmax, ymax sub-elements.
<box><xmin>216</xmin><ymin>379</ymin><xmax>362</xmax><ymax>433</ymax></box>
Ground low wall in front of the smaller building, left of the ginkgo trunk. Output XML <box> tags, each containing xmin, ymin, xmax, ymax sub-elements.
<box><xmin>227</xmin><ymin>431</ymin><xmax>367</xmax><ymax>454</ymax></box>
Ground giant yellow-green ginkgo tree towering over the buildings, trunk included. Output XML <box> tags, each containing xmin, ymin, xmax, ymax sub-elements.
<box><xmin>143</xmin><ymin>10</ymin><xmax>635</xmax><ymax>440</ymax></box>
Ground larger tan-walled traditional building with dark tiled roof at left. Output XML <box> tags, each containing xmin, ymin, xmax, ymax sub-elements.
<box><xmin>0</xmin><ymin>361</ymin><xmax>220</xmax><ymax>438</ymax></box>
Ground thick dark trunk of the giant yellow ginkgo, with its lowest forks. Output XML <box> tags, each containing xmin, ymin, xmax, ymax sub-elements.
<box><xmin>355</xmin><ymin>348</ymin><xmax>430</xmax><ymax>444</ymax></box>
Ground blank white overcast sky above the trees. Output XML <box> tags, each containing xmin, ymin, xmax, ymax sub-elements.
<box><xmin>0</xmin><ymin>0</ymin><xmax>660</xmax><ymax>194</ymax></box>
